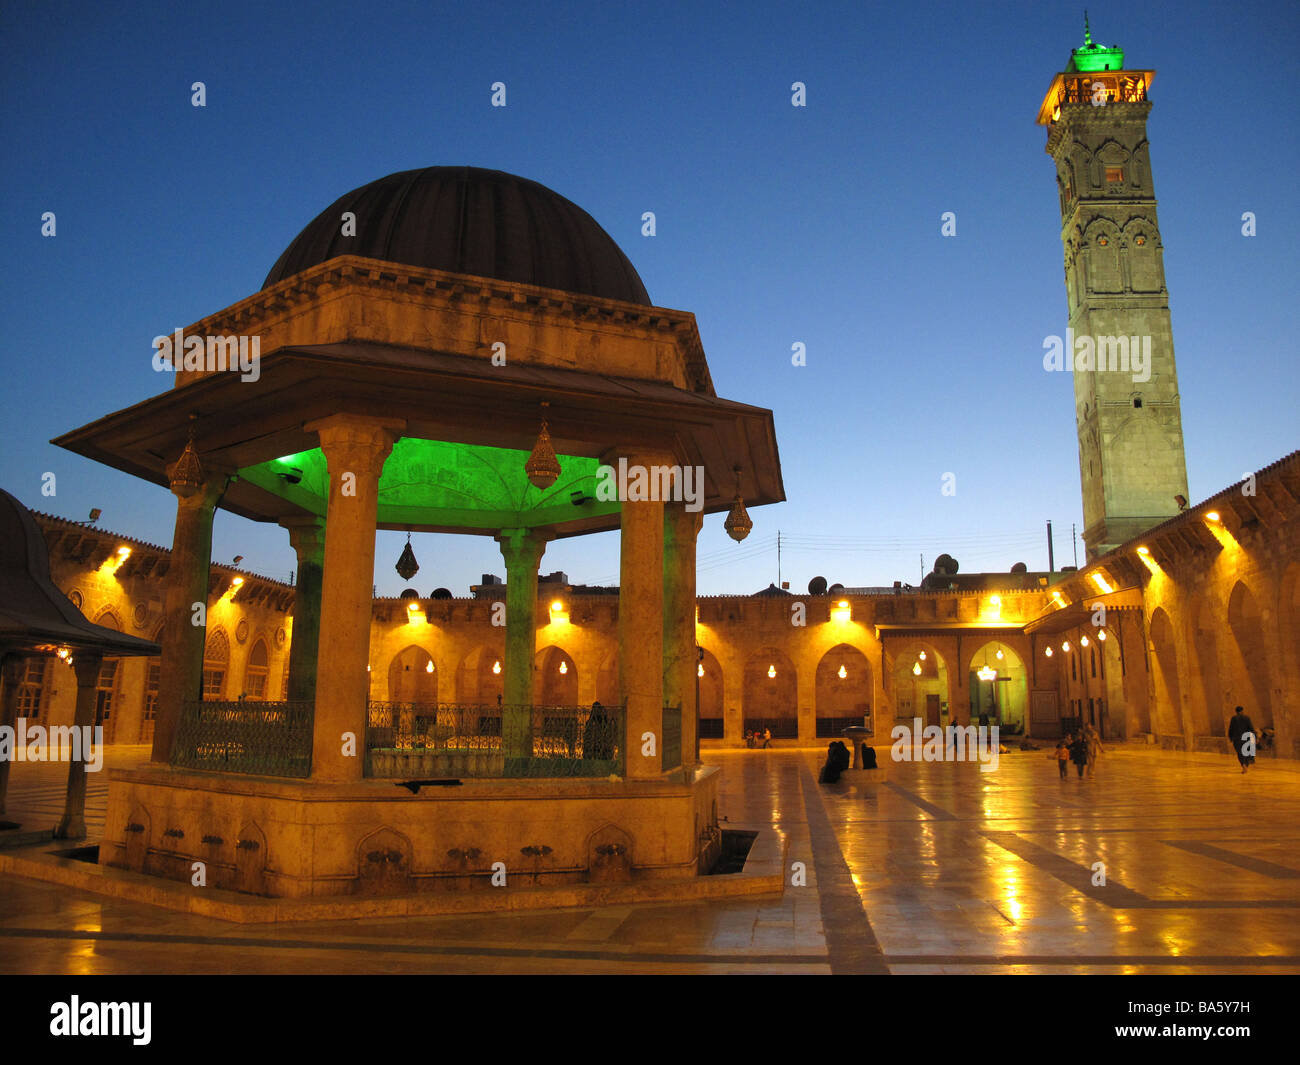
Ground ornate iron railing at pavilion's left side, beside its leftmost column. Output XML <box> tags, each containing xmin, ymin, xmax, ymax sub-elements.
<box><xmin>172</xmin><ymin>701</ymin><xmax>313</xmax><ymax>778</ymax></box>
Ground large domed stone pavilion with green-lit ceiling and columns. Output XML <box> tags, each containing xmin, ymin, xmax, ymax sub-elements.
<box><xmin>55</xmin><ymin>166</ymin><xmax>784</xmax><ymax>897</ymax></box>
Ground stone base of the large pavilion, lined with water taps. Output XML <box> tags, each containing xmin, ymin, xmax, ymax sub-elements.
<box><xmin>99</xmin><ymin>766</ymin><xmax>720</xmax><ymax>899</ymax></box>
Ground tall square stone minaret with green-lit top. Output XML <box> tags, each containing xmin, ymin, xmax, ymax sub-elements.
<box><xmin>1037</xmin><ymin>18</ymin><xmax>1187</xmax><ymax>559</ymax></box>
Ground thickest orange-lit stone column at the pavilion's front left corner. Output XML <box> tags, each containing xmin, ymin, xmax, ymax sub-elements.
<box><xmin>304</xmin><ymin>415</ymin><xmax>406</xmax><ymax>782</ymax></box>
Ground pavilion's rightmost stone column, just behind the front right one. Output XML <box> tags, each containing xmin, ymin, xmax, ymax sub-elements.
<box><xmin>663</xmin><ymin>503</ymin><xmax>703</xmax><ymax>766</ymax></box>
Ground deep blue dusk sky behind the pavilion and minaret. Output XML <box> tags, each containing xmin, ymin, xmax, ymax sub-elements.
<box><xmin>0</xmin><ymin>0</ymin><xmax>1300</xmax><ymax>594</ymax></box>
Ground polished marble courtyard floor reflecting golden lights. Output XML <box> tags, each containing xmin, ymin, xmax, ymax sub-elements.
<box><xmin>0</xmin><ymin>748</ymin><xmax>1300</xmax><ymax>974</ymax></box>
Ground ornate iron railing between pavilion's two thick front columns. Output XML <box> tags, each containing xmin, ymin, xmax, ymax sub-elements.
<box><xmin>365</xmin><ymin>702</ymin><xmax>626</xmax><ymax>780</ymax></box>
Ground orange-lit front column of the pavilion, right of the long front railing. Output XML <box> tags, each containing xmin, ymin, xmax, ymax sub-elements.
<box><xmin>619</xmin><ymin>449</ymin><xmax>672</xmax><ymax>779</ymax></box>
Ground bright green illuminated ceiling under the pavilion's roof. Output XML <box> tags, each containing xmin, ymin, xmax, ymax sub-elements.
<box><xmin>239</xmin><ymin>437</ymin><xmax>619</xmax><ymax>531</ymax></box>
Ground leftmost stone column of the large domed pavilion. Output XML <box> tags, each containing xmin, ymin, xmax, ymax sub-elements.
<box><xmin>151</xmin><ymin>467</ymin><xmax>229</xmax><ymax>762</ymax></box>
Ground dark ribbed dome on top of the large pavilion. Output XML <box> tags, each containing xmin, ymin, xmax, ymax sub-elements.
<box><xmin>263</xmin><ymin>166</ymin><xmax>651</xmax><ymax>307</ymax></box>
